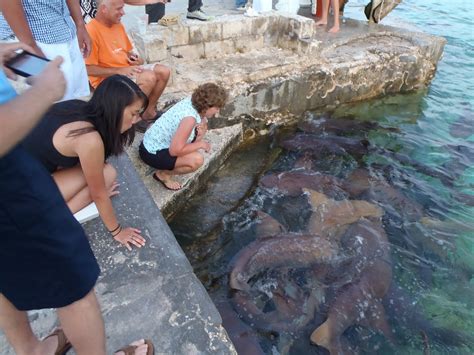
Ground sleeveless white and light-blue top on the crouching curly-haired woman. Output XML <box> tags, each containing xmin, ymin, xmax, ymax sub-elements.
<box><xmin>143</xmin><ymin>97</ymin><xmax>201</xmax><ymax>154</ymax></box>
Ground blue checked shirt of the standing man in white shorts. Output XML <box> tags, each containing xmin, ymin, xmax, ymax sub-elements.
<box><xmin>0</xmin><ymin>0</ymin><xmax>76</xmax><ymax>44</ymax></box>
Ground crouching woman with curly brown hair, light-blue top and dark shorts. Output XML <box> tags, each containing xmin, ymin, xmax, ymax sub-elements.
<box><xmin>139</xmin><ymin>83</ymin><xmax>227</xmax><ymax>190</ymax></box>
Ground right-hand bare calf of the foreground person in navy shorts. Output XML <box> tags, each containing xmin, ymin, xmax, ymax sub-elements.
<box><xmin>57</xmin><ymin>290</ymin><xmax>105</xmax><ymax>355</ymax></box>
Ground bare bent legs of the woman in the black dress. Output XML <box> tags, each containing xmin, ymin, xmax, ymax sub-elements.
<box><xmin>53</xmin><ymin>164</ymin><xmax>117</xmax><ymax>213</ymax></box>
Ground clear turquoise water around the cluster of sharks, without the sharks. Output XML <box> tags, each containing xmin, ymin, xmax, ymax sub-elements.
<box><xmin>171</xmin><ymin>0</ymin><xmax>474</xmax><ymax>354</ymax></box>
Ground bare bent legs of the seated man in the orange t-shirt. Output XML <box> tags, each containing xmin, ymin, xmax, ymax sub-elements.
<box><xmin>137</xmin><ymin>64</ymin><xmax>170</xmax><ymax>121</ymax></box>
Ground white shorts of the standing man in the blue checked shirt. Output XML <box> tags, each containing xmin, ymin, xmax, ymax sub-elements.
<box><xmin>36</xmin><ymin>37</ymin><xmax>90</xmax><ymax>101</ymax></box>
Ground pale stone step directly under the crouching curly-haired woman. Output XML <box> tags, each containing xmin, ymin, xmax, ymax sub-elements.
<box><xmin>127</xmin><ymin>124</ymin><xmax>242</xmax><ymax>219</ymax></box>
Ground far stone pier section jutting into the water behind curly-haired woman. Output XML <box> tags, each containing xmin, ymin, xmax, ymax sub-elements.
<box><xmin>130</xmin><ymin>16</ymin><xmax>446</xmax><ymax>129</ymax></box>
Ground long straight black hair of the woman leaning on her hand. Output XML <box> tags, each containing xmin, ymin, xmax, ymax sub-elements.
<box><xmin>67</xmin><ymin>75</ymin><xmax>148</xmax><ymax>159</ymax></box>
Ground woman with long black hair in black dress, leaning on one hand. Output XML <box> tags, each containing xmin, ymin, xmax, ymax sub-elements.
<box><xmin>23</xmin><ymin>75</ymin><xmax>148</xmax><ymax>250</ymax></box>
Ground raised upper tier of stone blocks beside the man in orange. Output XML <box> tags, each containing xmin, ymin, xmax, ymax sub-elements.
<box><xmin>131</xmin><ymin>12</ymin><xmax>316</xmax><ymax>62</ymax></box>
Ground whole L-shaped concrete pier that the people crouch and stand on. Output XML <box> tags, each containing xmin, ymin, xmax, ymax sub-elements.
<box><xmin>0</xmin><ymin>0</ymin><xmax>445</xmax><ymax>354</ymax></box>
